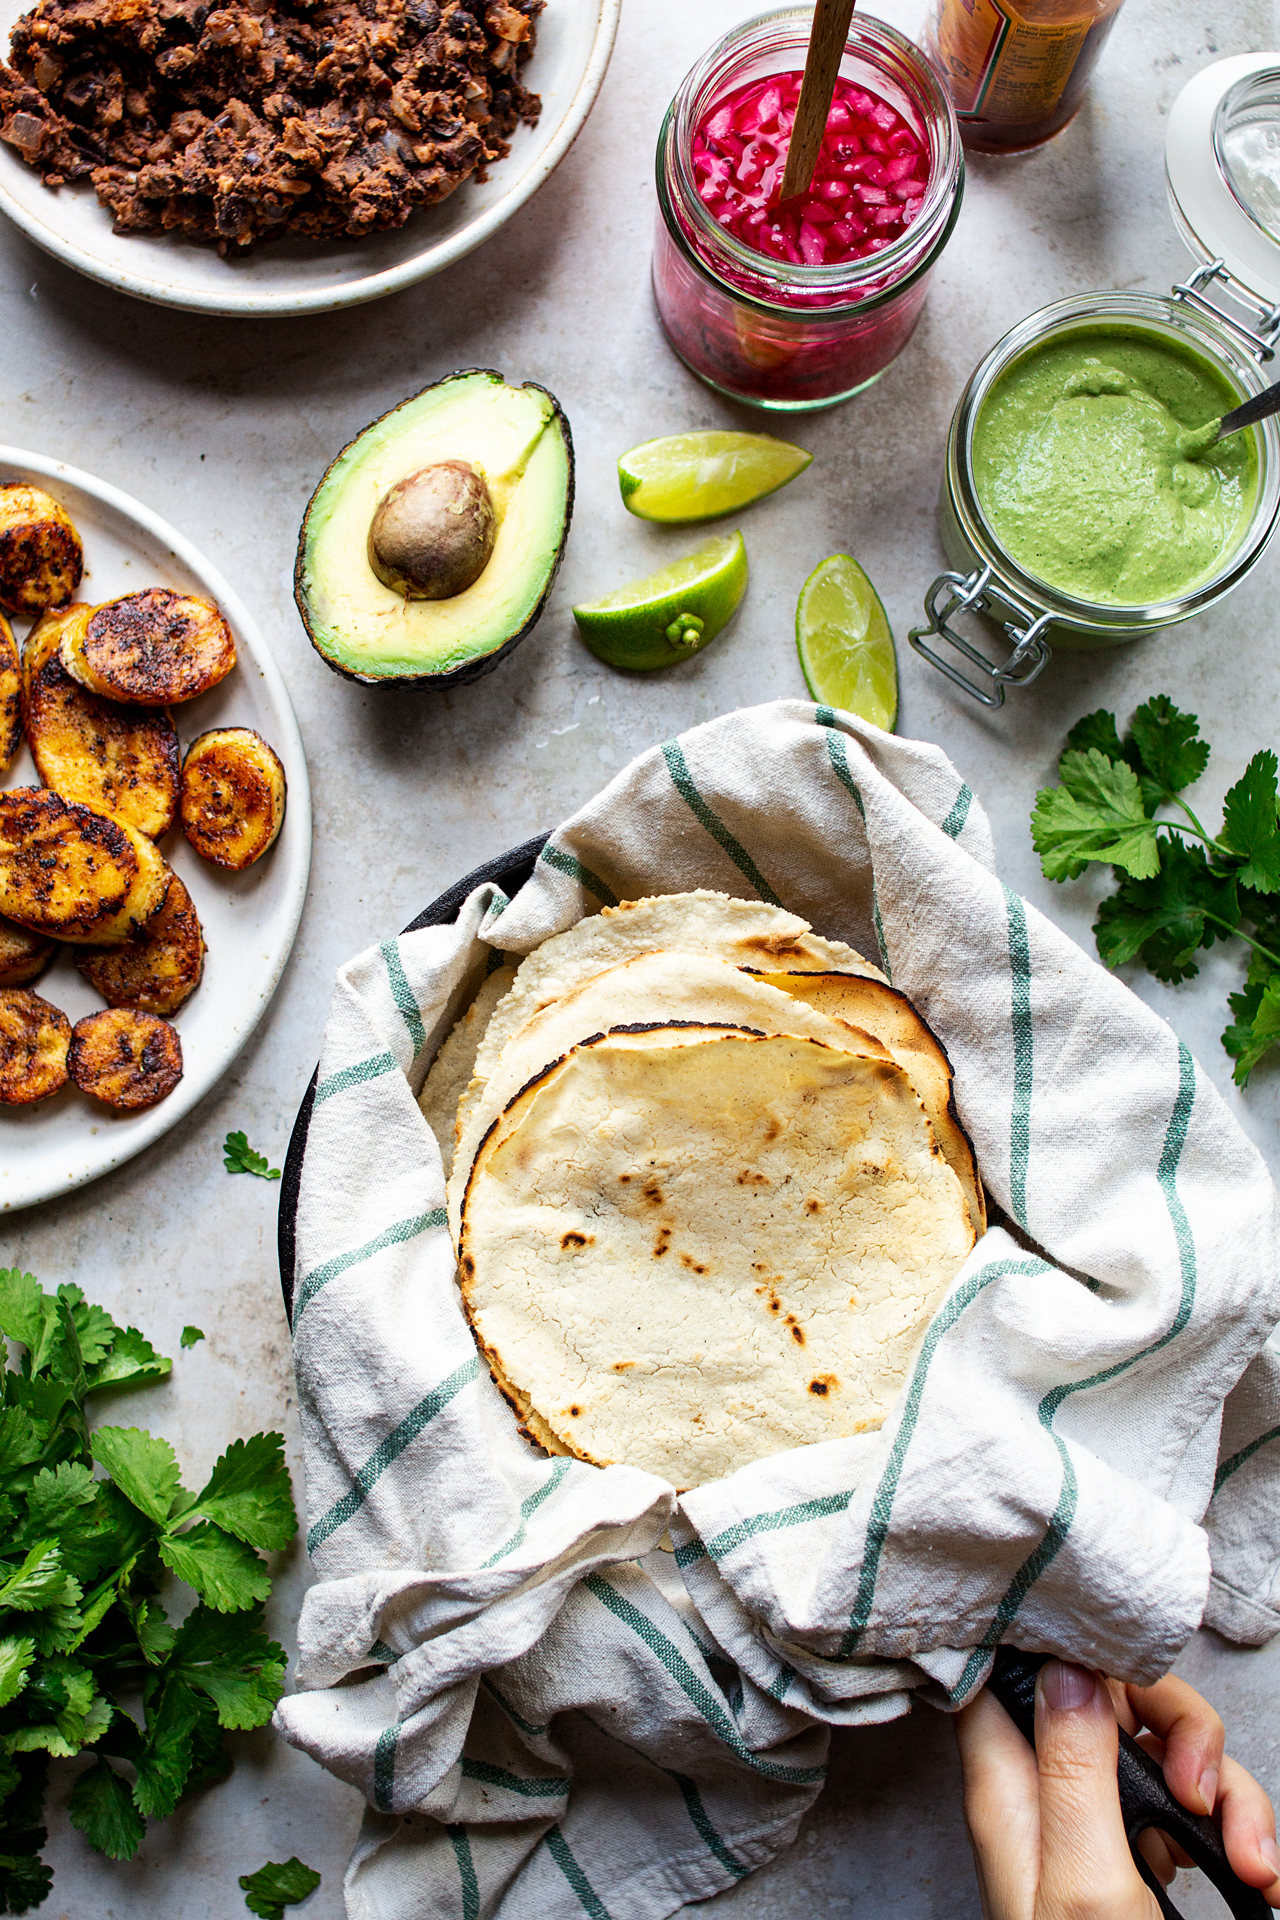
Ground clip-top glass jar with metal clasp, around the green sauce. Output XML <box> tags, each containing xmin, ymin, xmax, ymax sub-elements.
<box><xmin>910</xmin><ymin>284</ymin><xmax>1280</xmax><ymax>707</ymax></box>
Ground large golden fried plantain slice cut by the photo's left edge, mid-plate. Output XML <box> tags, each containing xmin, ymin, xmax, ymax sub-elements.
<box><xmin>0</xmin><ymin>787</ymin><xmax>169</xmax><ymax>945</ymax></box>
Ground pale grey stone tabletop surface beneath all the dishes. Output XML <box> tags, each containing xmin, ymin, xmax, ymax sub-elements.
<box><xmin>0</xmin><ymin>0</ymin><xmax>1280</xmax><ymax>1920</ymax></box>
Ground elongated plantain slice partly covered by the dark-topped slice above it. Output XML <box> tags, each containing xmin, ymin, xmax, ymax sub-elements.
<box><xmin>27</xmin><ymin>651</ymin><xmax>180</xmax><ymax>839</ymax></box>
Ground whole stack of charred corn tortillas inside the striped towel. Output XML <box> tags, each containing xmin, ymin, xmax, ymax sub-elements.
<box><xmin>420</xmin><ymin>891</ymin><xmax>986</xmax><ymax>1490</ymax></box>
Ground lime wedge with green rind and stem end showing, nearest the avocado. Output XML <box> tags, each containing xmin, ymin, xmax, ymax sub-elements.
<box><xmin>574</xmin><ymin>534</ymin><xmax>747</xmax><ymax>672</ymax></box>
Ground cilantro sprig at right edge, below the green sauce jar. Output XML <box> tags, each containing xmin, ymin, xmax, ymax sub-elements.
<box><xmin>1031</xmin><ymin>693</ymin><xmax>1280</xmax><ymax>1087</ymax></box>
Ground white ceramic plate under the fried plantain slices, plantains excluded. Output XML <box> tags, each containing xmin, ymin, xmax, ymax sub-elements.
<box><xmin>0</xmin><ymin>447</ymin><xmax>311</xmax><ymax>1212</ymax></box>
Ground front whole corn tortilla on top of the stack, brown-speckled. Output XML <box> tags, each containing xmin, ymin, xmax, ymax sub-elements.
<box><xmin>459</xmin><ymin>1036</ymin><xmax>973</xmax><ymax>1488</ymax></box>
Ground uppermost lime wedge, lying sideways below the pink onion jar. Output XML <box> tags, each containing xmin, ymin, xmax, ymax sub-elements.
<box><xmin>618</xmin><ymin>432</ymin><xmax>814</xmax><ymax>522</ymax></box>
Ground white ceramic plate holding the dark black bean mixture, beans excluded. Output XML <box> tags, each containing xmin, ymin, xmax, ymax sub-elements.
<box><xmin>0</xmin><ymin>0</ymin><xmax>622</xmax><ymax>317</ymax></box>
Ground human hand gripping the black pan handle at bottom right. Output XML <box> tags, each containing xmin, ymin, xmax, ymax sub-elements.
<box><xmin>956</xmin><ymin>1661</ymin><xmax>1280</xmax><ymax>1920</ymax></box>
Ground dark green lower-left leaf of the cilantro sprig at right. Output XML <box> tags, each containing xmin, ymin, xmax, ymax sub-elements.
<box><xmin>1094</xmin><ymin>837</ymin><xmax>1240</xmax><ymax>981</ymax></box>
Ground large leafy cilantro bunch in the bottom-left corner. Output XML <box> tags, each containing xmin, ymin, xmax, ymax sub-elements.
<box><xmin>0</xmin><ymin>1267</ymin><xmax>297</xmax><ymax>1914</ymax></box>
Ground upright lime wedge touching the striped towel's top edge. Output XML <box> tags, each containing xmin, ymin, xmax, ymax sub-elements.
<box><xmin>796</xmin><ymin>553</ymin><xmax>898</xmax><ymax>733</ymax></box>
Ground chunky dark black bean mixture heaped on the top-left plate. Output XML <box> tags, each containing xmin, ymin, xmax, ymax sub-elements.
<box><xmin>0</xmin><ymin>0</ymin><xmax>543</xmax><ymax>253</ymax></box>
